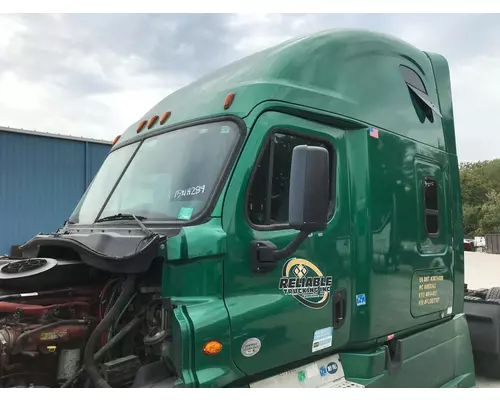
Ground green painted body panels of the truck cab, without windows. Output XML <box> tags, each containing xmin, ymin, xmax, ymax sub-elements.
<box><xmin>94</xmin><ymin>30</ymin><xmax>475</xmax><ymax>387</ymax></box>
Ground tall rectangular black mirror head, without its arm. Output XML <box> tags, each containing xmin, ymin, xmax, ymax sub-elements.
<box><xmin>288</xmin><ymin>145</ymin><xmax>330</xmax><ymax>233</ymax></box>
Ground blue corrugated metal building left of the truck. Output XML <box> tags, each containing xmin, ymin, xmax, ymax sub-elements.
<box><xmin>0</xmin><ymin>127</ymin><xmax>111</xmax><ymax>255</ymax></box>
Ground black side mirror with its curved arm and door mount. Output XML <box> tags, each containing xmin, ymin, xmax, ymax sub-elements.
<box><xmin>252</xmin><ymin>145</ymin><xmax>330</xmax><ymax>273</ymax></box>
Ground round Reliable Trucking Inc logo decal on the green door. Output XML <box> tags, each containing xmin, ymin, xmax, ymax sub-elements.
<box><xmin>279</xmin><ymin>258</ymin><xmax>333</xmax><ymax>309</ymax></box>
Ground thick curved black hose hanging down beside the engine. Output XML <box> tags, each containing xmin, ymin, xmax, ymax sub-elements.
<box><xmin>83</xmin><ymin>275</ymin><xmax>135</xmax><ymax>388</ymax></box>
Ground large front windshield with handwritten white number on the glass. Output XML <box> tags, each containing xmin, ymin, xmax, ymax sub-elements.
<box><xmin>69</xmin><ymin>121</ymin><xmax>239</xmax><ymax>224</ymax></box>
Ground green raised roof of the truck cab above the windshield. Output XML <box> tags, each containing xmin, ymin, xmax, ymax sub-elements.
<box><xmin>121</xmin><ymin>30</ymin><xmax>452</xmax><ymax>153</ymax></box>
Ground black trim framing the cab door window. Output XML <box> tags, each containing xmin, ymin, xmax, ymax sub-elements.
<box><xmin>245</xmin><ymin>126</ymin><xmax>337</xmax><ymax>231</ymax></box>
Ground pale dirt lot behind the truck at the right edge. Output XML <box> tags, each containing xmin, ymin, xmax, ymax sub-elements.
<box><xmin>465</xmin><ymin>252</ymin><xmax>500</xmax><ymax>388</ymax></box>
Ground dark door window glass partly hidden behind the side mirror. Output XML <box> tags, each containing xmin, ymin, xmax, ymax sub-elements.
<box><xmin>247</xmin><ymin>133</ymin><xmax>334</xmax><ymax>226</ymax></box>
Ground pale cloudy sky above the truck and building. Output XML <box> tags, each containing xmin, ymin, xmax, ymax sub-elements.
<box><xmin>0</xmin><ymin>14</ymin><xmax>500</xmax><ymax>161</ymax></box>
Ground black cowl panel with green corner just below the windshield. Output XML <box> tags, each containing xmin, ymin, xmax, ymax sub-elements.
<box><xmin>19</xmin><ymin>218</ymin><xmax>226</xmax><ymax>274</ymax></box>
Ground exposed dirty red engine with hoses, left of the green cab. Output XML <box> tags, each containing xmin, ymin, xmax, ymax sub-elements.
<box><xmin>0</xmin><ymin>258</ymin><xmax>170</xmax><ymax>388</ymax></box>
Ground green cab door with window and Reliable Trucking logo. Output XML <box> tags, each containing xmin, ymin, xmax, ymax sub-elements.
<box><xmin>222</xmin><ymin>112</ymin><xmax>352</xmax><ymax>375</ymax></box>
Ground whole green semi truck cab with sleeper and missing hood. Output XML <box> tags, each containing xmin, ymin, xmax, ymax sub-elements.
<box><xmin>0</xmin><ymin>30</ymin><xmax>475</xmax><ymax>388</ymax></box>
